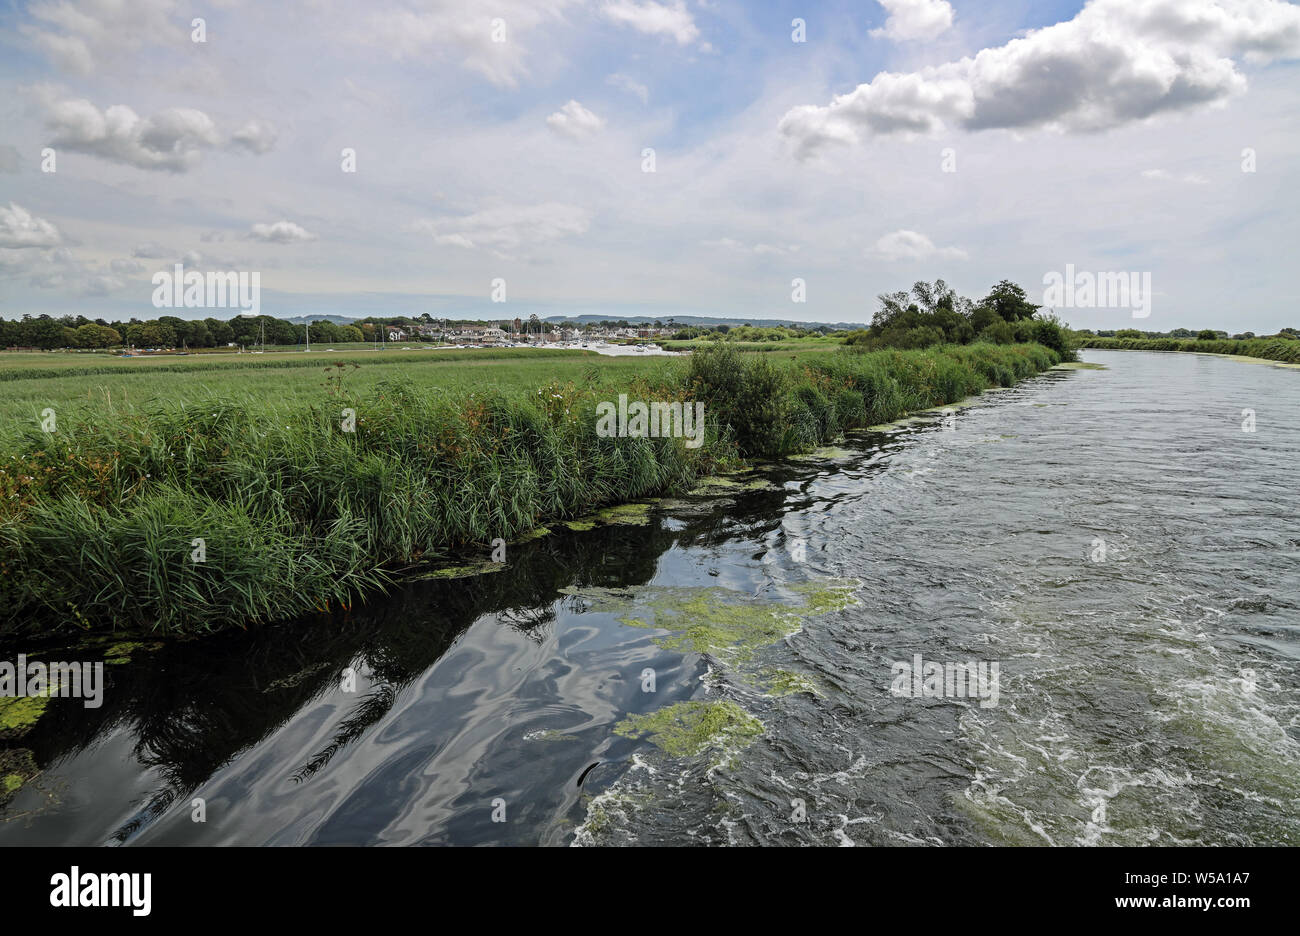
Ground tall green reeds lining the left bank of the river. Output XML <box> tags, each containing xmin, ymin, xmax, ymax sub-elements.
<box><xmin>0</xmin><ymin>345</ymin><xmax>1060</xmax><ymax>633</ymax></box>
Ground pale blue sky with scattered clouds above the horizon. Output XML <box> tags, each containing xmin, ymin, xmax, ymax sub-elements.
<box><xmin>0</xmin><ymin>0</ymin><xmax>1300</xmax><ymax>333</ymax></box>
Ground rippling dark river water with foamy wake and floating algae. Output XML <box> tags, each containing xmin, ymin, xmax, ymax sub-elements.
<box><xmin>0</xmin><ymin>351</ymin><xmax>1300</xmax><ymax>845</ymax></box>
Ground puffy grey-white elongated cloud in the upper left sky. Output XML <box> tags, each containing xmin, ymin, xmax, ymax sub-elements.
<box><xmin>46</xmin><ymin>98</ymin><xmax>221</xmax><ymax>172</ymax></box>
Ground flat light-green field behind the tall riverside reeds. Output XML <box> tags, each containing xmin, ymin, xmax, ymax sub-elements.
<box><xmin>0</xmin><ymin>348</ymin><xmax>667</xmax><ymax>421</ymax></box>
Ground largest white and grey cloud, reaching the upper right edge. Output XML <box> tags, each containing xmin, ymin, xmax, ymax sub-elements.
<box><xmin>780</xmin><ymin>0</ymin><xmax>1300</xmax><ymax>157</ymax></box>
